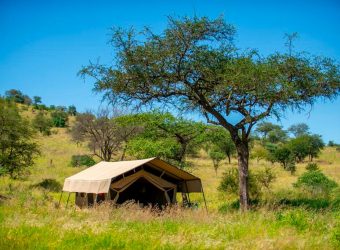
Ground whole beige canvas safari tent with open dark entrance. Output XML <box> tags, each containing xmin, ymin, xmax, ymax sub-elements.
<box><xmin>60</xmin><ymin>158</ymin><xmax>205</xmax><ymax>207</ymax></box>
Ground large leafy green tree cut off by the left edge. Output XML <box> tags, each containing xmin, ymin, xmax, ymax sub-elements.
<box><xmin>0</xmin><ymin>99</ymin><xmax>39</xmax><ymax>178</ymax></box>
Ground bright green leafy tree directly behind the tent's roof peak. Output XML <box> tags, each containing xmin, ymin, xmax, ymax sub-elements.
<box><xmin>128</xmin><ymin>111</ymin><xmax>206</xmax><ymax>166</ymax></box>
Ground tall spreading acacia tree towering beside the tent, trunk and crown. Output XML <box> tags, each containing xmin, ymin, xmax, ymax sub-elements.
<box><xmin>80</xmin><ymin>17</ymin><xmax>340</xmax><ymax>210</ymax></box>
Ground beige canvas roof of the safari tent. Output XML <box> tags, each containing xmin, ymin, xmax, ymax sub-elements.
<box><xmin>63</xmin><ymin>158</ymin><xmax>201</xmax><ymax>193</ymax></box>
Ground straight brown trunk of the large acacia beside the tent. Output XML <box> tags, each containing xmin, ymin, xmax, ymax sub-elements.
<box><xmin>236</xmin><ymin>142</ymin><xmax>249</xmax><ymax>211</ymax></box>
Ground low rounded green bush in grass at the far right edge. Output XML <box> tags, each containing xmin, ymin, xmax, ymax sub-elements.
<box><xmin>294</xmin><ymin>170</ymin><xmax>338</xmax><ymax>197</ymax></box>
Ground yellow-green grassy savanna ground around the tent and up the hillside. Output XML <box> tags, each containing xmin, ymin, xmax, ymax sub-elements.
<box><xmin>0</xmin><ymin>117</ymin><xmax>340</xmax><ymax>249</ymax></box>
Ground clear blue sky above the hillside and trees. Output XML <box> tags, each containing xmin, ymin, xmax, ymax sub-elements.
<box><xmin>0</xmin><ymin>0</ymin><xmax>340</xmax><ymax>143</ymax></box>
